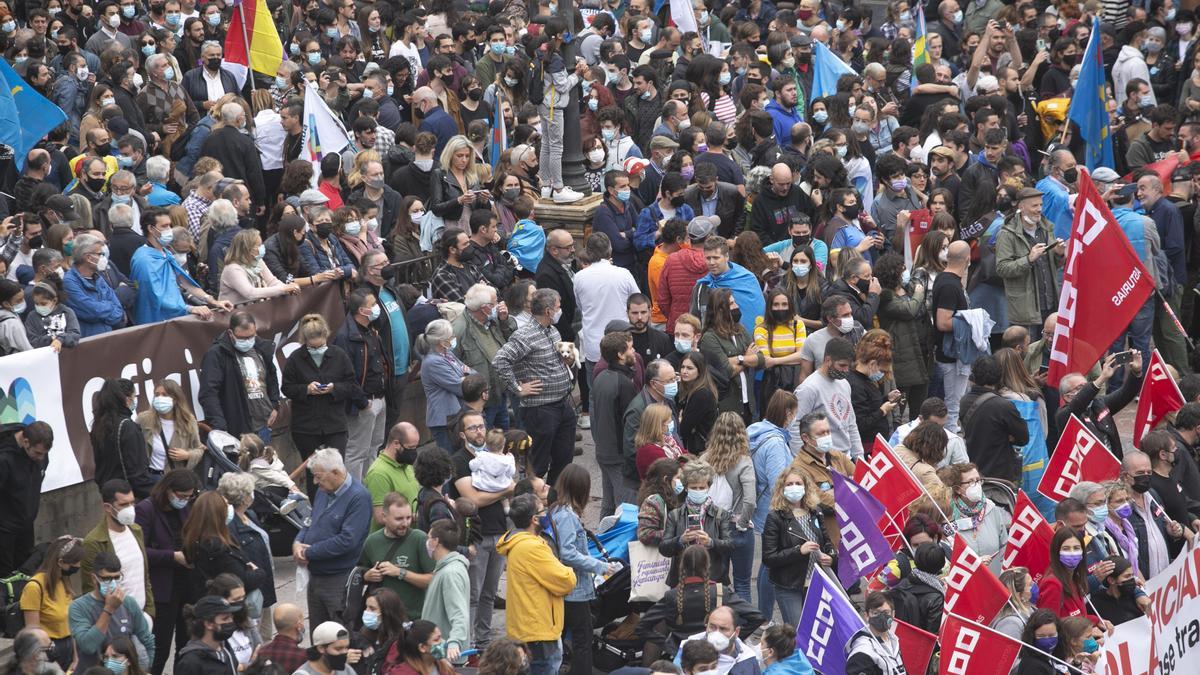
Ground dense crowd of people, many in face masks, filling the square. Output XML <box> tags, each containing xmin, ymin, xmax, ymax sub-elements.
<box><xmin>0</xmin><ymin>0</ymin><xmax>1200</xmax><ymax>675</ymax></box>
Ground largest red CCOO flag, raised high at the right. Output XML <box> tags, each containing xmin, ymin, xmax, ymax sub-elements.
<box><xmin>1048</xmin><ymin>171</ymin><xmax>1154</xmax><ymax>387</ymax></box>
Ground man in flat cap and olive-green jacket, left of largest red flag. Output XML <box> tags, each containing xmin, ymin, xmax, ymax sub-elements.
<box><xmin>996</xmin><ymin>187</ymin><xmax>1067</xmax><ymax>333</ymax></box>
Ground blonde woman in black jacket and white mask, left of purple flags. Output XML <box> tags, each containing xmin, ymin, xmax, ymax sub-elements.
<box><xmin>751</xmin><ymin>468</ymin><xmax>833</xmax><ymax>626</ymax></box>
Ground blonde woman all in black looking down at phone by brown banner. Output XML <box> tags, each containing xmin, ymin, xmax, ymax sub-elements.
<box><xmin>280</xmin><ymin>313</ymin><xmax>359</xmax><ymax>485</ymax></box>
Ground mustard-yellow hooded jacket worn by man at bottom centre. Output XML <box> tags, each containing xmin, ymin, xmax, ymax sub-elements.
<box><xmin>496</xmin><ymin>530</ymin><xmax>575</xmax><ymax>643</ymax></box>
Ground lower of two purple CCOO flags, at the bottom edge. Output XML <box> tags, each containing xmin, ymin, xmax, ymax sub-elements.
<box><xmin>796</xmin><ymin>566</ymin><xmax>866</xmax><ymax>673</ymax></box>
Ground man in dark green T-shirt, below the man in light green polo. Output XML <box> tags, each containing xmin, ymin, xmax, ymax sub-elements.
<box><xmin>359</xmin><ymin>487</ymin><xmax>433</xmax><ymax>621</ymax></box>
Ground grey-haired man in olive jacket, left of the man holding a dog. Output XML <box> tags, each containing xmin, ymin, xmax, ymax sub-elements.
<box><xmin>452</xmin><ymin>283</ymin><xmax>517</xmax><ymax>429</ymax></box>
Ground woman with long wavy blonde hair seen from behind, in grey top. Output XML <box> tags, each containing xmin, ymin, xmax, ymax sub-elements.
<box><xmin>702</xmin><ymin>412</ymin><xmax>757</xmax><ymax>598</ymax></box>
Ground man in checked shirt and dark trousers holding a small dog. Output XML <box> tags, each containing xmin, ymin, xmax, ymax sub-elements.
<box><xmin>492</xmin><ymin>288</ymin><xmax>577</xmax><ymax>484</ymax></box>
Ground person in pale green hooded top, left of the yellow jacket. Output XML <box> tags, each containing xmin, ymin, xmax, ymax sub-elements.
<box><xmin>421</xmin><ymin>519</ymin><xmax>470</xmax><ymax>663</ymax></box>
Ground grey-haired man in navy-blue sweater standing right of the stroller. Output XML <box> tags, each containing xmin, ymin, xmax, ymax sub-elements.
<box><xmin>292</xmin><ymin>448</ymin><xmax>372</xmax><ymax>626</ymax></box>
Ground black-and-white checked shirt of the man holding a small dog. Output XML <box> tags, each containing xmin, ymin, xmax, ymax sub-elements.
<box><xmin>492</xmin><ymin>321</ymin><xmax>571</xmax><ymax>408</ymax></box>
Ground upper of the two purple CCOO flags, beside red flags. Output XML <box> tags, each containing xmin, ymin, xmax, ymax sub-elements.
<box><xmin>833</xmin><ymin>471</ymin><xmax>893</xmax><ymax>589</ymax></box>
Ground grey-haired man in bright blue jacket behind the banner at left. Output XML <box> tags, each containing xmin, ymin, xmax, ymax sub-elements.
<box><xmin>62</xmin><ymin>233</ymin><xmax>130</xmax><ymax>338</ymax></box>
